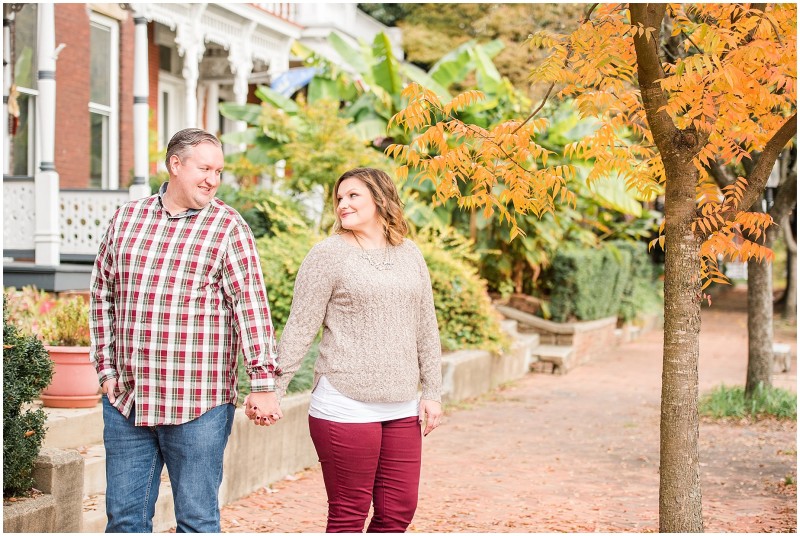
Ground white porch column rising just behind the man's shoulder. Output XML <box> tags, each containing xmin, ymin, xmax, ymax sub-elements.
<box><xmin>128</xmin><ymin>13</ymin><xmax>151</xmax><ymax>199</ymax></box>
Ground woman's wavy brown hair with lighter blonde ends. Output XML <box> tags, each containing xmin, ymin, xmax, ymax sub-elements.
<box><xmin>333</xmin><ymin>168</ymin><xmax>408</xmax><ymax>246</ymax></box>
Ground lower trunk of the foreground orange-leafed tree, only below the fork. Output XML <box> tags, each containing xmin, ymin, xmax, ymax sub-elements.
<box><xmin>659</xmin><ymin>166</ymin><xmax>703</xmax><ymax>532</ymax></box>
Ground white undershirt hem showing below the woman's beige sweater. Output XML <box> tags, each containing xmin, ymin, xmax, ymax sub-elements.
<box><xmin>308</xmin><ymin>376</ymin><xmax>419</xmax><ymax>423</ymax></box>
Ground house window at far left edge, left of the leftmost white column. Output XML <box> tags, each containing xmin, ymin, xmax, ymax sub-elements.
<box><xmin>3</xmin><ymin>4</ymin><xmax>39</xmax><ymax>177</ymax></box>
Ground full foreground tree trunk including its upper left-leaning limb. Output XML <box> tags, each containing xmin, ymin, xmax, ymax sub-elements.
<box><xmin>629</xmin><ymin>3</ymin><xmax>707</xmax><ymax>532</ymax></box>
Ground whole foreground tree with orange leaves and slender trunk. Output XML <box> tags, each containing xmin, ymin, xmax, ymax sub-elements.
<box><xmin>387</xmin><ymin>4</ymin><xmax>797</xmax><ymax>532</ymax></box>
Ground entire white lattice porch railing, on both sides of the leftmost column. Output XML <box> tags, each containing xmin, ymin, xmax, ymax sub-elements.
<box><xmin>3</xmin><ymin>179</ymin><xmax>130</xmax><ymax>255</ymax></box>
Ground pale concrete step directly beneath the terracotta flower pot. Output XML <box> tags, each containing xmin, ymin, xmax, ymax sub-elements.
<box><xmin>42</xmin><ymin>404</ymin><xmax>103</xmax><ymax>449</ymax></box>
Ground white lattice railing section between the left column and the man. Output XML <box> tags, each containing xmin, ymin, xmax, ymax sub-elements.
<box><xmin>59</xmin><ymin>190</ymin><xmax>130</xmax><ymax>255</ymax></box>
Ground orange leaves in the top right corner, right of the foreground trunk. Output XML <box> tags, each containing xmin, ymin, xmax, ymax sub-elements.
<box><xmin>661</xmin><ymin>4</ymin><xmax>797</xmax><ymax>169</ymax></box>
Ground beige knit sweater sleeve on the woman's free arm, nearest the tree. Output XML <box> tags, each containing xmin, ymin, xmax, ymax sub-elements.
<box><xmin>414</xmin><ymin>245</ymin><xmax>442</xmax><ymax>402</ymax></box>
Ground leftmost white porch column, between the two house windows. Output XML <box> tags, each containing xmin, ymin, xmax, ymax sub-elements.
<box><xmin>33</xmin><ymin>3</ymin><xmax>61</xmax><ymax>266</ymax></box>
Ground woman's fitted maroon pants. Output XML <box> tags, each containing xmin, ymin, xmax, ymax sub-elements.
<box><xmin>308</xmin><ymin>416</ymin><xmax>422</xmax><ymax>532</ymax></box>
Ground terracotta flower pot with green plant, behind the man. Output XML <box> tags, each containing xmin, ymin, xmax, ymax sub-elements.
<box><xmin>41</xmin><ymin>346</ymin><xmax>100</xmax><ymax>408</ymax></box>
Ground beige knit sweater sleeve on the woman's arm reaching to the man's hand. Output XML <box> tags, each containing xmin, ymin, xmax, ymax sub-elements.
<box><xmin>276</xmin><ymin>245</ymin><xmax>334</xmax><ymax>397</ymax></box>
